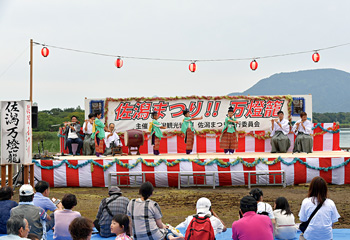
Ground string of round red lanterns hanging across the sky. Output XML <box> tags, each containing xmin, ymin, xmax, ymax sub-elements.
<box><xmin>34</xmin><ymin>42</ymin><xmax>350</xmax><ymax>73</ymax></box>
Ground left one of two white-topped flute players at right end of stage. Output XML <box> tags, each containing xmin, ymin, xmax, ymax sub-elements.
<box><xmin>270</xmin><ymin>111</ymin><xmax>290</xmax><ymax>153</ymax></box>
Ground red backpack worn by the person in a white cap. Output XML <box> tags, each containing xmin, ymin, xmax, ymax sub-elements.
<box><xmin>185</xmin><ymin>214</ymin><xmax>215</xmax><ymax>240</ymax></box>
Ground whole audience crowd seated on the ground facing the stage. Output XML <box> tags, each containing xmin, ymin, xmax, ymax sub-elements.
<box><xmin>0</xmin><ymin>177</ymin><xmax>340</xmax><ymax>240</ymax></box>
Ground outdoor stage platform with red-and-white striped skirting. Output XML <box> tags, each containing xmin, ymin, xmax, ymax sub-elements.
<box><xmin>33</xmin><ymin>151</ymin><xmax>350</xmax><ymax>187</ymax></box>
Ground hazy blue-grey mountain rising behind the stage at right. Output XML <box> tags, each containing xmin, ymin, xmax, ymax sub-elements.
<box><xmin>229</xmin><ymin>69</ymin><xmax>350</xmax><ymax>113</ymax></box>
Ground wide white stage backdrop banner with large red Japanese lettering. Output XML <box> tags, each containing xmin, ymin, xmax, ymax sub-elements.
<box><xmin>85</xmin><ymin>95</ymin><xmax>312</xmax><ymax>133</ymax></box>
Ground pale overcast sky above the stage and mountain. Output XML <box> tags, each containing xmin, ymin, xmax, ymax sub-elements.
<box><xmin>0</xmin><ymin>0</ymin><xmax>350</xmax><ymax>110</ymax></box>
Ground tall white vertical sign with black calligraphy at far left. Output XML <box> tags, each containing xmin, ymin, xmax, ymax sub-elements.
<box><xmin>0</xmin><ymin>101</ymin><xmax>32</xmax><ymax>164</ymax></box>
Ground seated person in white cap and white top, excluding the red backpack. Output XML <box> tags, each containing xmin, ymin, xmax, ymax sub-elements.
<box><xmin>176</xmin><ymin>197</ymin><xmax>227</xmax><ymax>236</ymax></box>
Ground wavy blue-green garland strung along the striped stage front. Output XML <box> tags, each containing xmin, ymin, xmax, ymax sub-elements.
<box><xmin>32</xmin><ymin>156</ymin><xmax>350</xmax><ymax>172</ymax></box>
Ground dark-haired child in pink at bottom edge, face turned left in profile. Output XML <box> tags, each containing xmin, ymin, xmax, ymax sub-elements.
<box><xmin>111</xmin><ymin>214</ymin><xmax>131</xmax><ymax>240</ymax></box>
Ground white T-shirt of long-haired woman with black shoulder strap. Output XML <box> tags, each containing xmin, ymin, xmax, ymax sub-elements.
<box><xmin>299</xmin><ymin>197</ymin><xmax>340</xmax><ymax>240</ymax></box>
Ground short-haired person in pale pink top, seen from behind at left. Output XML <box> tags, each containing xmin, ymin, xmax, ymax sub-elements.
<box><xmin>53</xmin><ymin>194</ymin><xmax>81</xmax><ymax>240</ymax></box>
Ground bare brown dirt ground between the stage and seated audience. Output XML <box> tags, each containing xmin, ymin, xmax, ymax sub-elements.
<box><xmin>15</xmin><ymin>185</ymin><xmax>350</xmax><ymax>228</ymax></box>
